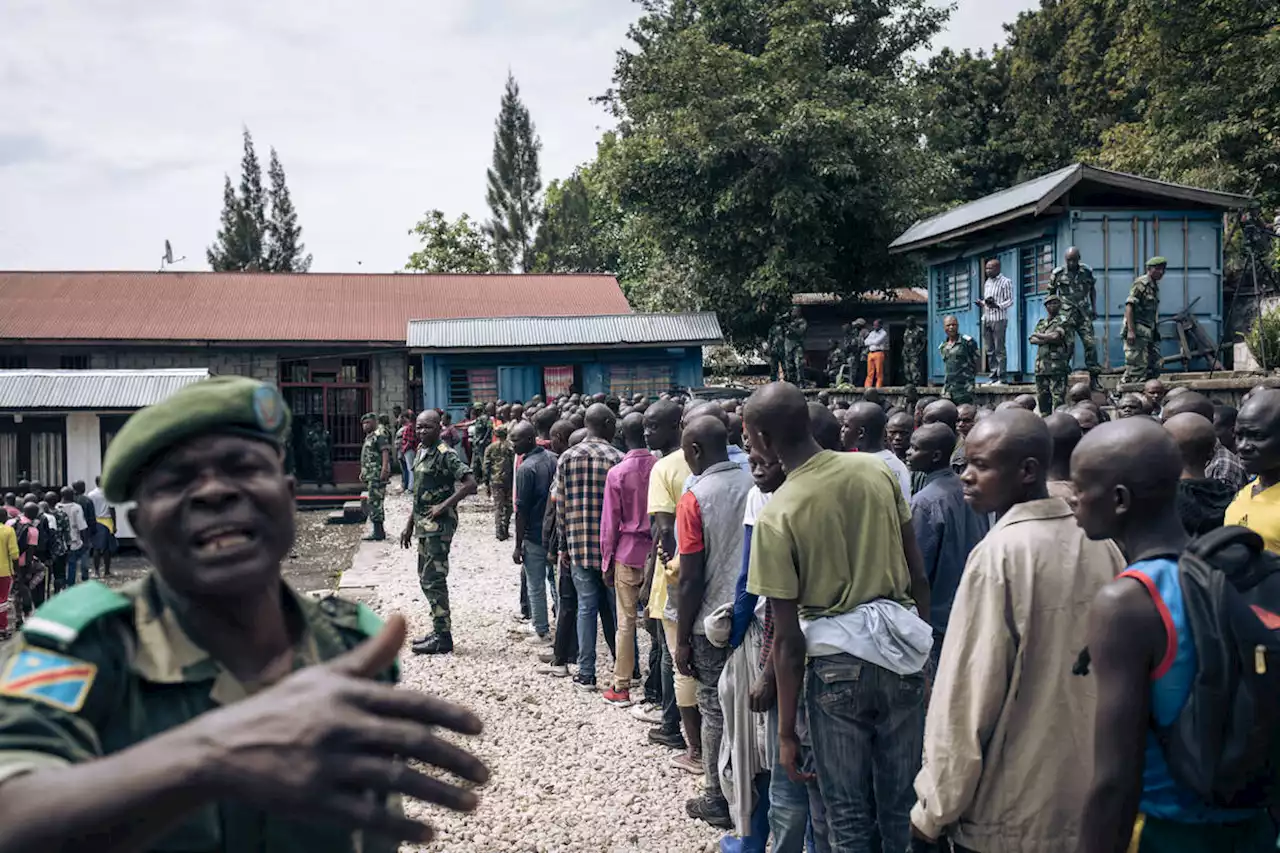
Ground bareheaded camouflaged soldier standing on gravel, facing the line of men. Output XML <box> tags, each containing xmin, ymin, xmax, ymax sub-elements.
<box><xmin>401</xmin><ymin>411</ymin><xmax>477</xmax><ymax>654</ymax></box>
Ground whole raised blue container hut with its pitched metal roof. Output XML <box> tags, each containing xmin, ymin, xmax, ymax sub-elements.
<box><xmin>890</xmin><ymin>164</ymin><xmax>1249</xmax><ymax>383</ymax></box>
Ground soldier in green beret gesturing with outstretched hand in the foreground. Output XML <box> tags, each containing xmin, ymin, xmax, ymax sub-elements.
<box><xmin>0</xmin><ymin>377</ymin><xmax>486</xmax><ymax>853</ymax></box>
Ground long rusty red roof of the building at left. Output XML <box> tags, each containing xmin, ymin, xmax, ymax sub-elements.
<box><xmin>0</xmin><ymin>272</ymin><xmax>631</xmax><ymax>346</ymax></box>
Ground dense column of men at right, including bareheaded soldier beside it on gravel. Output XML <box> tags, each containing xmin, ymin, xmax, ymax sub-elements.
<box><xmin>391</xmin><ymin>379</ymin><xmax>1280</xmax><ymax>853</ymax></box>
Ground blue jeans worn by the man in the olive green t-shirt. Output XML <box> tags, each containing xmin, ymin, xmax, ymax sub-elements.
<box><xmin>805</xmin><ymin>654</ymin><xmax>924</xmax><ymax>853</ymax></box>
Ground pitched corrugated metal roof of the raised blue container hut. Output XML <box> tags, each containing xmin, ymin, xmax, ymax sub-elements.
<box><xmin>890</xmin><ymin>163</ymin><xmax>1249</xmax><ymax>252</ymax></box>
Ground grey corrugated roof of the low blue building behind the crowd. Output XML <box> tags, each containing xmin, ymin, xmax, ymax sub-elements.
<box><xmin>408</xmin><ymin>313</ymin><xmax>724</xmax><ymax>350</ymax></box>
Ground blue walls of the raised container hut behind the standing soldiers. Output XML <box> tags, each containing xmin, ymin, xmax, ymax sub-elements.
<box><xmin>928</xmin><ymin>209</ymin><xmax>1222</xmax><ymax>382</ymax></box>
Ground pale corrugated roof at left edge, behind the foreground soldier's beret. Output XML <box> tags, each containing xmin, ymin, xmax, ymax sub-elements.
<box><xmin>0</xmin><ymin>369</ymin><xmax>209</xmax><ymax>411</ymax></box>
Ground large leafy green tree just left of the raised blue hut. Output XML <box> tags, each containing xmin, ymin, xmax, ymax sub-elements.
<box><xmin>604</xmin><ymin>0</ymin><xmax>946</xmax><ymax>342</ymax></box>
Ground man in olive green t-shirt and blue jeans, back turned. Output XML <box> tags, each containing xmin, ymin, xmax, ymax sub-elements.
<box><xmin>744</xmin><ymin>383</ymin><xmax>929</xmax><ymax>850</ymax></box>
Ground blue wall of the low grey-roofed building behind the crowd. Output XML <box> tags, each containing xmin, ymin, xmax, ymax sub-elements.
<box><xmin>420</xmin><ymin>347</ymin><xmax>703</xmax><ymax>418</ymax></box>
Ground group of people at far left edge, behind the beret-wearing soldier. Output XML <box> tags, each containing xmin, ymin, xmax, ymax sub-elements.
<box><xmin>0</xmin><ymin>480</ymin><xmax>116</xmax><ymax>639</ymax></box>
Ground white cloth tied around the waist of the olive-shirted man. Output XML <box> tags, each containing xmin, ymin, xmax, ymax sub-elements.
<box><xmin>800</xmin><ymin>598</ymin><xmax>933</xmax><ymax>675</ymax></box>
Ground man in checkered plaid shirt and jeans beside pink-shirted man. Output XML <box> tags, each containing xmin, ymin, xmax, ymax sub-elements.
<box><xmin>554</xmin><ymin>403</ymin><xmax>622</xmax><ymax>692</ymax></box>
